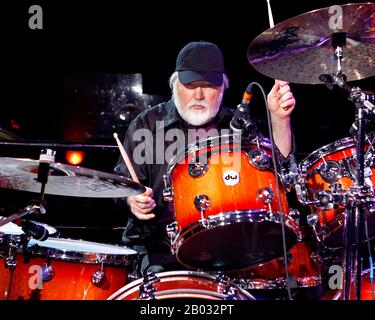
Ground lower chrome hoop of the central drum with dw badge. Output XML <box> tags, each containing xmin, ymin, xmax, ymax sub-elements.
<box><xmin>172</xmin><ymin>209</ymin><xmax>302</xmax><ymax>252</ymax></box>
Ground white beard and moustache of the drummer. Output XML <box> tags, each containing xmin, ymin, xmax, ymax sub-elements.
<box><xmin>173</xmin><ymin>93</ymin><xmax>223</xmax><ymax>126</ymax></box>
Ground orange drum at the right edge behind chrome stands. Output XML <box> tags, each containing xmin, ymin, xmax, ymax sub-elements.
<box><xmin>300</xmin><ymin>138</ymin><xmax>375</xmax><ymax>248</ymax></box>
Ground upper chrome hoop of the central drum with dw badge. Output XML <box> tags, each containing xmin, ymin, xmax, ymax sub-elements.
<box><xmin>167</xmin><ymin>134</ymin><xmax>272</xmax><ymax>185</ymax></box>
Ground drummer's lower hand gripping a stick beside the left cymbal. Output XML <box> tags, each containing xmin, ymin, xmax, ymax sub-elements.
<box><xmin>126</xmin><ymin>187</ymin><xmax>156</xmax><ymax>220</ymax></box>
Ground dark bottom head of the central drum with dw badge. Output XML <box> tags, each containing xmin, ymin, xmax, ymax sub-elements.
<box><xmin>177</xmin><ymin>212</ymin><xmax>297</xmax><ymax>271</ymax></box>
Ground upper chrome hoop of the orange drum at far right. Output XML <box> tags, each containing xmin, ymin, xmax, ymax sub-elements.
<box><xmin>299</xmin><ymin>137</ymin><xmax>355</xmax><ymax>172</ymax></box>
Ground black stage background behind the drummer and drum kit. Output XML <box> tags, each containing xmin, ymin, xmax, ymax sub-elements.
<box><xmin>0</xmin><ymin>0</ymin><xmax>375</xmax><ymax>239</ymax></box>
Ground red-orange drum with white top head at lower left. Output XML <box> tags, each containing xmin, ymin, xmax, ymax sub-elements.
<box><xmin>0</xmin><ymin>238</ymin><xmax>138</xmax><ymax>300</ymax></box>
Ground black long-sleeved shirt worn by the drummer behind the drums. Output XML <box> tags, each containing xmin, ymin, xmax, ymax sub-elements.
<box><xmin>114</xmin><ymin>100</ymin><xmax>288</xmax><ymax>245</ymax></box>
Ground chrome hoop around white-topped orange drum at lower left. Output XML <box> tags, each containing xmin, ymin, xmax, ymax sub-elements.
<box><xmin>25</xmin><ymin>238</ymin><xmax>138</xmax><ymax>266</ymax></box>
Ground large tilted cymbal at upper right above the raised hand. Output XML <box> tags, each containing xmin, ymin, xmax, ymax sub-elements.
<box><xmin>247</xmin><ymin>3</ymin><xmax>375</xmax><ymax>84</ymax></box>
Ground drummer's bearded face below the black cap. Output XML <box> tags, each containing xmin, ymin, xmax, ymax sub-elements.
<box><xmin>173</xmin><ymin>79</ymin><xmax>224</xmax><ymax>126</ymax></box>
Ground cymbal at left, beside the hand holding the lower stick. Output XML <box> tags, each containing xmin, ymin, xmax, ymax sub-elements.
<box><xmin>0</xmin><ymin>157</ymin><xmax>146</xmax><ymax>198</ymax></box>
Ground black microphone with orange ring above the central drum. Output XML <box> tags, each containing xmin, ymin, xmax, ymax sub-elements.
<box><xmin>229</xmin><ymin>82</ymin><xmax>256</xmax><ymax>134</ymax></box>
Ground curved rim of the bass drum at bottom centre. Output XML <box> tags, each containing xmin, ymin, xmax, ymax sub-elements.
<box><xmin>107</xmin><ymin>270</ymin><xmax>255</xmax><ymax>300</ymax></box>
